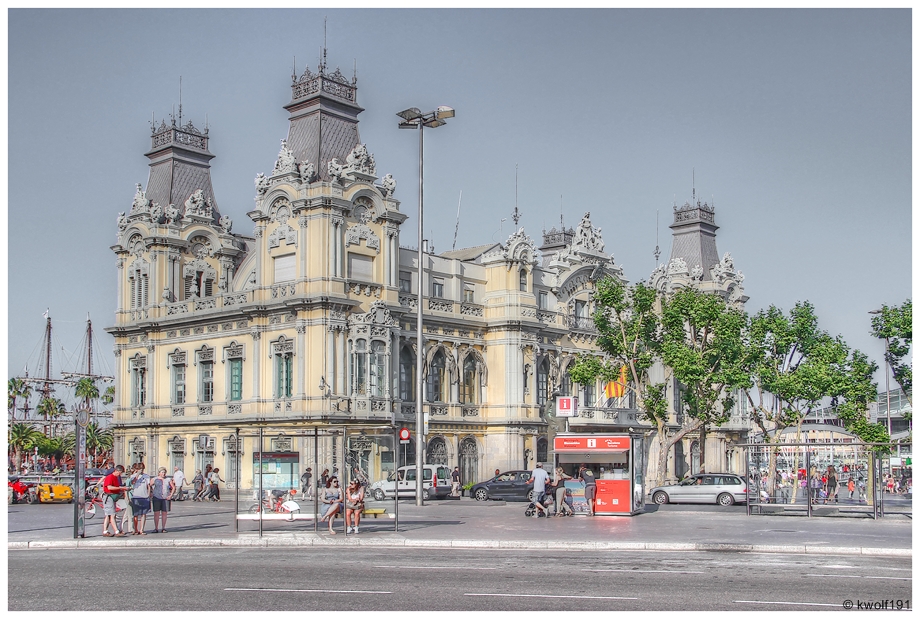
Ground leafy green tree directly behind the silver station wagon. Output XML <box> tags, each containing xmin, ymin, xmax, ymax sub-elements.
<box><xmin>661</xmin><ymin>288</ymin><xmax>750</xmax><ymax>468</ymax></box>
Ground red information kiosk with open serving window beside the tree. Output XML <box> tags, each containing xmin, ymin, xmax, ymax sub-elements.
<box><xmin>553</xmin><ymin>434</ymin><xmax>646</xmax><ymax>516</ymax></box>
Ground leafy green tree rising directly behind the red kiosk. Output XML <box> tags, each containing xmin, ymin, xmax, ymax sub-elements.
<box><xmin>569</xmin><ymin>277</ymin><xmax>683</xmax><ymax>481</ymax></box>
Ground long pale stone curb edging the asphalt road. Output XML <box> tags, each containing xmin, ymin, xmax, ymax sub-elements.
<box><xmin>7</xmin><ymin>535</ymin><xmax>913</xmax><ymax>557</ymax></box>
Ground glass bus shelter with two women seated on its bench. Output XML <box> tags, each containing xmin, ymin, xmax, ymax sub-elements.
<box><xmin>225</xmin><ymin>423</ymin><xmax>399</xmax><ymax>537</ymax></box>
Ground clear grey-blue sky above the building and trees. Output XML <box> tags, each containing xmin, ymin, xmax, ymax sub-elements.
<box><xmin>8</xmin><ymin>9</ymin><xmax>911</xmax><ymax>406</ymax></box>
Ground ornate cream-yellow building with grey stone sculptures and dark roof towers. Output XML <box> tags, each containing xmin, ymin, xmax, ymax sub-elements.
<box><xmin>108</xmin><ymin>54</ymin><xmax>743</xmax><ymax>488</ymax></box>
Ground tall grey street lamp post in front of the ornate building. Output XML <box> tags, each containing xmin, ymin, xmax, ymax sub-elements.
<box><xmin>396</xmin><ymin>105</ymin><xmax>454</xmax><ymax>506</ymax></box>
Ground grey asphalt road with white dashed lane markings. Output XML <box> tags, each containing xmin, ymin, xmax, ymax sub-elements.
<box><xmin>8</xmin><ymin>547</ymin><xmax>913</xmax><ymax>613</ymax></box>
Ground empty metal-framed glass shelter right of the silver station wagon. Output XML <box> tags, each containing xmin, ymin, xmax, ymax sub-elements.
<box><xmin>739</xmin><ymin>441</ymin><xmax>911</xmax><ymax>518</ymax></box>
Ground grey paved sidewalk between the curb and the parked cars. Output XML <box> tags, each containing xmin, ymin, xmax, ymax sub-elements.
<box><xmin>7</xmin><ymin>497</ymin><xmax>912</xmax><ymax>557</ymax></box>
